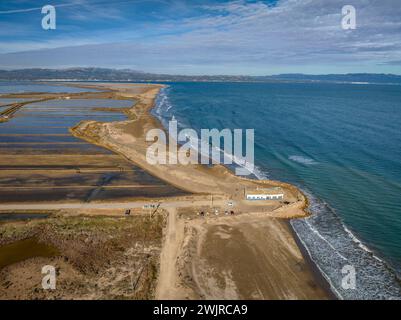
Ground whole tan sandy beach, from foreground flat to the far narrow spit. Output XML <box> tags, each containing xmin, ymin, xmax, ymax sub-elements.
<box><xmin>65</xmin><ymin>84</ymin><xmax>328</xmax><ymax>299</ymax></box>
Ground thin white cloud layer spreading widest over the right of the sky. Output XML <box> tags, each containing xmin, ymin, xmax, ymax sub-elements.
<box><xmin>0</xmin><ymin>0</ymin><xmax>401</xmax><ymax>73</ymax></box>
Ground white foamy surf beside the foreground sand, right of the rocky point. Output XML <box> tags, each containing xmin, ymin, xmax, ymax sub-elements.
<box><xmin>291</xmin><ymin>192</ymin><xmax>401</xmax><ymax>300</ymax></box>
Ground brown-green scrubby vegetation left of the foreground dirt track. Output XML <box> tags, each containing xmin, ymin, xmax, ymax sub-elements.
<box><xmin>0</xmin><ymin>213</ymin><xmax>165</xmax><ymax>299</ymax></box>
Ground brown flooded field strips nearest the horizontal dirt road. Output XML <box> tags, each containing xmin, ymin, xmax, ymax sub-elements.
<box><xmin>0</xmin><ymin>155</ymin><xmax>185</xmax><ymax>203</ymax></box>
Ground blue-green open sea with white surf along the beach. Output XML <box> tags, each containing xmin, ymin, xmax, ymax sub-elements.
<box><xmin>153</xmin><ymin>83</ymin><xmax>401</xmax><ymax>299</ymax></box>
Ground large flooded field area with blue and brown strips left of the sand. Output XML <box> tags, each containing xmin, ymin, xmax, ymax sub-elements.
<box><xmin>0</xmin><ymin>83</ymin><xmax>184</xmax><ymax>203</ymax></box>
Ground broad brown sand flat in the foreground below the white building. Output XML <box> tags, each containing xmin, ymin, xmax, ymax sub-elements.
<box><xmin>179</xmin><ymin>215</ymin><xmax>327</xmax><ymax>300</ymax></box>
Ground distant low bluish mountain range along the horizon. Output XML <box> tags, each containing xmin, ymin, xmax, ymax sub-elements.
<box><xmin>0</xmin><ymin>68</ymin><xmax>401</xmax><ymax>84</ymax></box>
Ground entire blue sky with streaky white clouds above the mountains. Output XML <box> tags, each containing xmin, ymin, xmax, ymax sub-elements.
<box><xmin>0</xmin><ymin>0</ymin><xmax>401</xmax><ymax>75</ymax></box>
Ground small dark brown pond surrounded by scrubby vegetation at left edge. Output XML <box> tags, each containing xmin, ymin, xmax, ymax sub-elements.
<box><xmin>0</xmin><ymin>238</ymin><xmax>59</xmax><ymax>269</ymax></box>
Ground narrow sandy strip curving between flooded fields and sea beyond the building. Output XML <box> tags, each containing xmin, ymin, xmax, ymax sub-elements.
<box><xmin>70</xmin><ymin>84</ymin><xmax>308</xmax><ymax>210</ymax></box>
